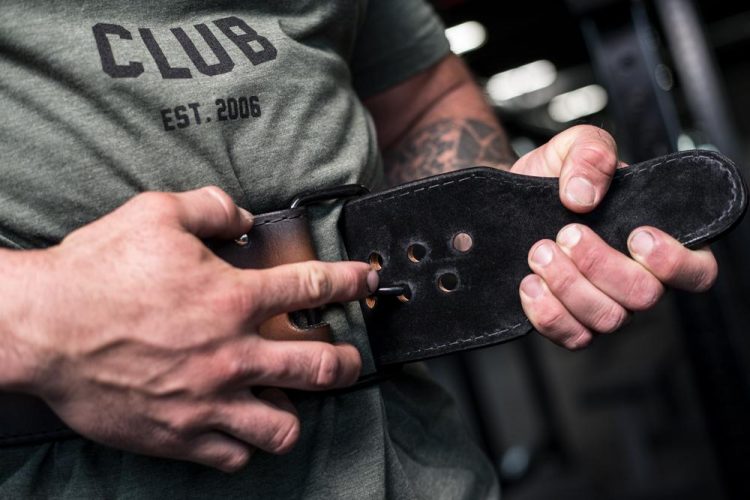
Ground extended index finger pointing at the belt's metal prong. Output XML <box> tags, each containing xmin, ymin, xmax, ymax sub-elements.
<box><xmin>244</xmin><ymin>261</ymin><xmax>378</xmax><ymax>322</ymax></box>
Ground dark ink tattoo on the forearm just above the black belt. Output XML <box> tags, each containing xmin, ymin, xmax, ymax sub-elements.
<box><xmin>384</xmin><ymin>118</ymin><xmax>516</xmax><ymax>185</ymax></box>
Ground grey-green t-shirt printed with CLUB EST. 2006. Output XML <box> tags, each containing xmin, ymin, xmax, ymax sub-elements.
<box><xmin>0</xmin><ymin>0</ymin><xmax>497</xmax><ymax>498</ymax></box>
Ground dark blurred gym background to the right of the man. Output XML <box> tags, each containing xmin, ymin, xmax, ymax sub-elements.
<box><xmin>429</xmin><ymin>0</ymin><xmax>750</xmax><ymax>500</ymax></box>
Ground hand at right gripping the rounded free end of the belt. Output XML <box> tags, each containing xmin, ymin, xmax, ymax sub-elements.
<box><xmin>511</xmin><ymin>125</ymin><xmax>718</xmax><ymax>349</ymax></box>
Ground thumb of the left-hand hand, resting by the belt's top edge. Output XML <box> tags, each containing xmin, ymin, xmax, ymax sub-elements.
<box><xmin>174</xmin><ymin>186</ymin><xmax>253</xmax><ymax>238</ymax></box>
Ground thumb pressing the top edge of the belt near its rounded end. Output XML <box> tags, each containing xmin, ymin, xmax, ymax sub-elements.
<box><xmin>551</xmin><ymin>125</ymin><xmax>619</xmax><ymax>213</ymax></box>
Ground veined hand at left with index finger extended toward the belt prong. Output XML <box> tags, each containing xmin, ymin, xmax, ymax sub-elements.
<box><xmin>0</xmin><ymin>187</ymin><xmax>377</xmax><ymax>471</ymax></box>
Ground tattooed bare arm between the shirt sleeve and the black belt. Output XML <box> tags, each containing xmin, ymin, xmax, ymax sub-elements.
<box><xmin>371</xmin><ymin>56</ymin><xmax>517</xmax><ymax>185</ymax></box>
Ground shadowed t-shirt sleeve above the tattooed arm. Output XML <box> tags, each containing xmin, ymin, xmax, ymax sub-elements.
<box><xmin>351</xmin><ymin>0</ymin><xmax>450</xmax><ymax>99</ymax></box>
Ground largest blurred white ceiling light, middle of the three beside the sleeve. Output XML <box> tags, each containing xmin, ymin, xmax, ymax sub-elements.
<box><xmin>487</xmin><ymin>60</ymin><xmax>557</xmax><ymax>104</ymax></box>
